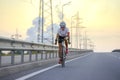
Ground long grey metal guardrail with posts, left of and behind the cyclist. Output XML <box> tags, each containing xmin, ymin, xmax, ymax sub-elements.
<box><xmin>0</xmin><ymin>37</ymin><xmax>91</xmax><ymax>67</ymax></box>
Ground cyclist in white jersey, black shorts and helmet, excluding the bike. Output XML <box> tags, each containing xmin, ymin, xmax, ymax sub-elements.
<box><xmin>55</xmin><ymin>21</ymin><xmax>70</xmax><ymax>64</ymax></box>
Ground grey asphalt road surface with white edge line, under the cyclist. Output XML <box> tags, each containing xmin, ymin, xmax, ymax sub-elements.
<box><xmin>0</xmin><ymin>53</ymin><xmax>120</xmax><ymax>80</ymax></box>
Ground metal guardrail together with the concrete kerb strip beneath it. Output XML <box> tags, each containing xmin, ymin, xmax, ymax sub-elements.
<box><xmin>0</xmin><ymin>37</ymin><xmax>92</xmax><ymax>77</ymax></box>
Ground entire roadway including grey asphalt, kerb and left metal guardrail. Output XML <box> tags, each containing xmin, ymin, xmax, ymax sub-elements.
<box><xmin>0</xmin><ymin>38</ymin><xmax>120</xmax><ymax>80</ymax></box>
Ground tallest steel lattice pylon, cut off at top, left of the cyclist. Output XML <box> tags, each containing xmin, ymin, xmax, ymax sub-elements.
<box><xmin>37</xmin><ymin>0</ymin><xmax>54</xmax><ymax>44</ymax></box>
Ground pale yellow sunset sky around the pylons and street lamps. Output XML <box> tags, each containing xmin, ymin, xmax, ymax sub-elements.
<box><xmin>0</xmin><ymin>0</ymin><xmax>120</xmax><ymax>52</ymax></box>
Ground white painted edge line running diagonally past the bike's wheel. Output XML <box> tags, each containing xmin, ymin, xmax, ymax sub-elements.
<box><xmin>15</xmin><ymin>53</ymin><xmax>91</xmax><ymax>80</ymax></box>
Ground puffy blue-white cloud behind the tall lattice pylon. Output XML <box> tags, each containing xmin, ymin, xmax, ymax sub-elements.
<box><xmin>26</xmin><ymin>17</ymin><xmax>59</xmax><ymax>44</ymax></box>
